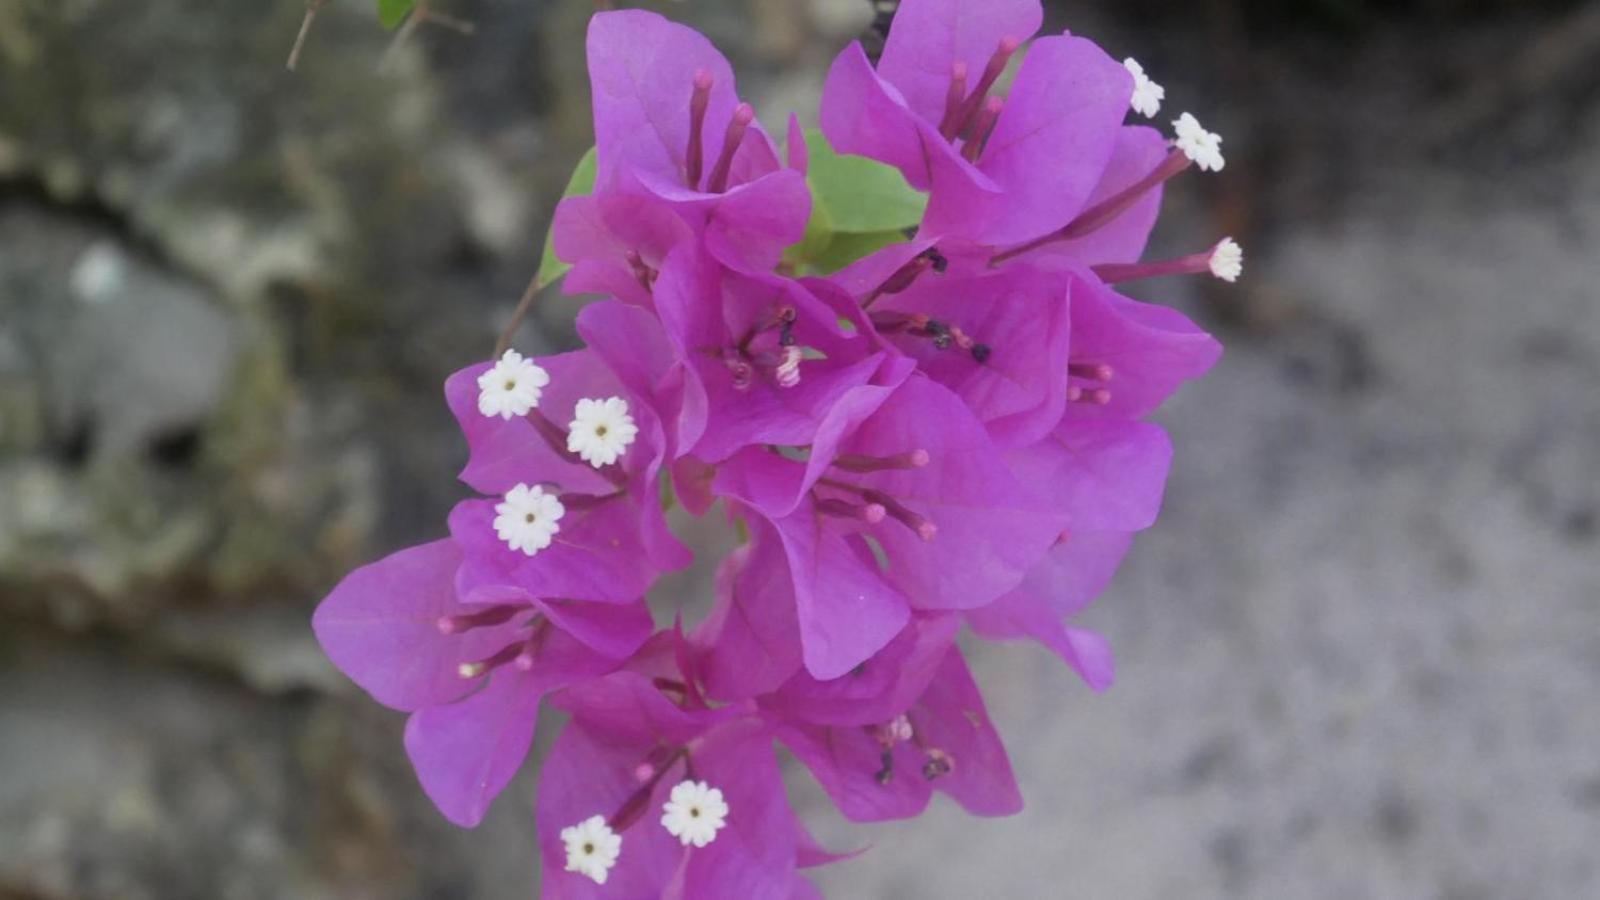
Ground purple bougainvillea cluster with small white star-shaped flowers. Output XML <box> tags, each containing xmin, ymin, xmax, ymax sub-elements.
<box><xmin>315</xmin><ymin>0</ymin><xmax>1243</xmax><ymax>898</ymax></box>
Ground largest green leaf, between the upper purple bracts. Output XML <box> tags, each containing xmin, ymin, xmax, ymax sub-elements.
<box><xmin>805</xmin><ymin>128</ymin><xmax>928</xmax><ymax>234</ymax></box>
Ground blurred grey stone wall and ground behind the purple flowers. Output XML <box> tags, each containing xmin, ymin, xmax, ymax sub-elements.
<box><xmin>0</xmin><ymin>0</ymin><xmax>1600</xmax><ymax>900</ymax></box>
